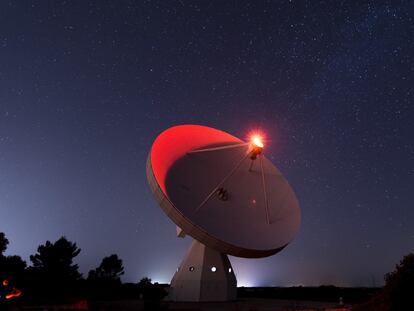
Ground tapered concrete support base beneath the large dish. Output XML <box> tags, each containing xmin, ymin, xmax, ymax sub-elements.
<box><xmin>169</xmin><ymin>240</ymin><xmax>237</xmax><ymax>301</ymax></box>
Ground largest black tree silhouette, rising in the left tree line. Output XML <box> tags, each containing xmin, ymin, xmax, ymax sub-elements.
<box><xmin>30</xmin><ymin>237</ymin><xmax>81</xmax><ymax>281</ymax></box>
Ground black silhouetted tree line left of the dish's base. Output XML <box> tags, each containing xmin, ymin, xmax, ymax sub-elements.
<box><xmin>0</xmin><ymin>232</ymin><xmax>164</xmax><ymax>303</ymax></box>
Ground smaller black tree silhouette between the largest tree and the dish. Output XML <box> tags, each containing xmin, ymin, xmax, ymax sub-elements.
<box><xmin>88</xmin><ymin>254</ymin><xmax>124</xmax><ymax>282</ymax></box>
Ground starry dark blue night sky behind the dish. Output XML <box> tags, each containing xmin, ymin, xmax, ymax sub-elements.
<box><xmin>0</xmin><ymin>0</ymin><xmax>414</xmax><ymax>286</ymax></box>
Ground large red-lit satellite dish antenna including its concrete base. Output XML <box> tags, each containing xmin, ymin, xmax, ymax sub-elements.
<box><xmin>147</xmin><ymin>125</ymin><xmax>300</xmax><ymax>301</ymax></box>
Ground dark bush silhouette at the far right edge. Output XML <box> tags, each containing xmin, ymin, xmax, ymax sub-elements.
<box><xmin>384</xmin><ymin>254</ymin><xmax>414</xmax><ymax>311</ymax></box>
